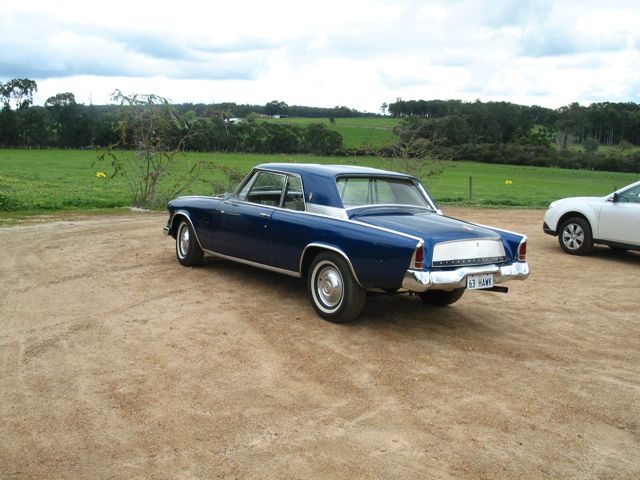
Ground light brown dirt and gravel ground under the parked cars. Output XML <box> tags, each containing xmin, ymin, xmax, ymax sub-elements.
<box><xmin>0</xmin><ymin>208</ymin><xmax>640</xmax><ymax>479</ymax></box>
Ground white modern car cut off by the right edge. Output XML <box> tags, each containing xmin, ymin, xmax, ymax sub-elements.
<box><xmin>542</xmin><ymin>182</ymin><xmax>640</xmax><ymax>255</ymax></box>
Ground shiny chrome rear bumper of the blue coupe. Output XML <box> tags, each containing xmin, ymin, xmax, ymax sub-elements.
<box><xmin>402</xmin><ymin>262</ymin><xmax>529</xmax><ymax>292</ymax></box>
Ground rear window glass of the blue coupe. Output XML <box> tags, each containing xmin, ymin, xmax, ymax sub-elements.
<box><xmin>336</xmin><ymin>176</ymin><xmax>431</xmax><ymax>208</ymax></box>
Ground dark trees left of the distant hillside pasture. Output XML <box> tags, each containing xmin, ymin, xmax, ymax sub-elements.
<box><xmin>0</xmin><ymin>80</ymin><xmax>346</xmax><ymax>155</ymax></box>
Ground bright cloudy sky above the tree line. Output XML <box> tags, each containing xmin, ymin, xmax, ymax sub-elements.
<box><xmin>0</xmin><ymin>0</ymin><xmax>640</xmax><ymax>113</ymax></box>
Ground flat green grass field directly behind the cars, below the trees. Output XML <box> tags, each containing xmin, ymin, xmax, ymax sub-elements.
<box><xmin>0</xmin><ymin>150</ymin><xmax>638</xmax><ymax>217</ymax></box>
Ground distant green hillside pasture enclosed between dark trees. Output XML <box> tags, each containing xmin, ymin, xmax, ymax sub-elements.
<box><xmin>261</xmin><ymin>117</ymin><xmax>400</xmax><ymax>150</ymax></box>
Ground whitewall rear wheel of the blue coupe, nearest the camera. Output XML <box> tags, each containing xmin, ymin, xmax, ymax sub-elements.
<box><xmin>307</xmin><ymin>252</ymin><xmax>367</xmax><ymax>323</ymax></box>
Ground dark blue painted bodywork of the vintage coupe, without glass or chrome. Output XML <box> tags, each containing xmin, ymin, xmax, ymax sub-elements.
<box><xmin>168</xmin><ymin>164</ymin><xmax>524</xmax><ymax>288</ymax></box>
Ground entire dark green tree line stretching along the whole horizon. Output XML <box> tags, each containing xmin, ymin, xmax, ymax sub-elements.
<box><xmin>0</xmin><ymin>78</ymin><xmax>640</xmax><ymax>172</ymax></box>
